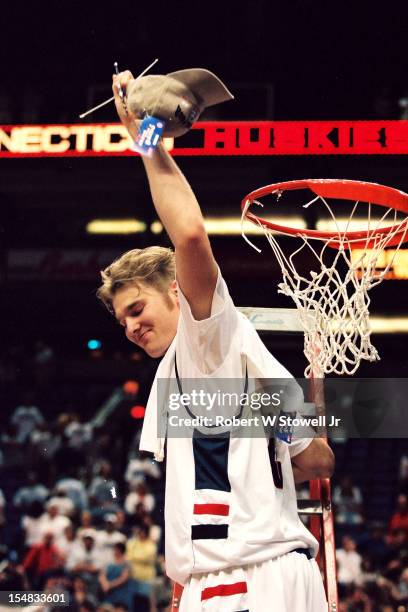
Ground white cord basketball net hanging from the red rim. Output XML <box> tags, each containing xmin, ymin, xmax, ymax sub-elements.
<box><xmin>241</xmin><ymin>182</ymin><xmax>408</xmax><ymax>378</ymax></box>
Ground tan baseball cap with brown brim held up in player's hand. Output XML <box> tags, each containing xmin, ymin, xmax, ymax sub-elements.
<box><xmin>127</xmin><ymin>68</ymin><xmax>234</xmax><ymax>137</ymax></box>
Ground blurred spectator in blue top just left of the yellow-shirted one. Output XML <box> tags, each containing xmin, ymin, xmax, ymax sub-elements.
<box><xmin>99</xmin><ymin>542</ymin><xmax>133</xmax><ymax>609</ymax></box>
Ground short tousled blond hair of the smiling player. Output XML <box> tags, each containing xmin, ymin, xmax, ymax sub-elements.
<box><xmin>96</xmin><ymin>246</ymin><xmax>176</xmax><ymax>314</ymax></box>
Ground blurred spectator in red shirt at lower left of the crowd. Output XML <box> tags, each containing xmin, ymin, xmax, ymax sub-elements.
<box><xmin>23</xmin><ymin>531</ymin><xmax>64</xmax><ymax>588</ymax></box>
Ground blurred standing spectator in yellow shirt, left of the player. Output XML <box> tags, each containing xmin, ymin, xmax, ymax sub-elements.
<box><xmin>126</xmin><ymin>526</ymin><xmax>157</xmax><ymax>610</ymax></box>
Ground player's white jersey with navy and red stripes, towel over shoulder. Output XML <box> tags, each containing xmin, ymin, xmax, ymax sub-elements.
<box><xmin>140</xmin><ymin>275</ymin><xmax>318</xmax><ymax>584</ymax></box>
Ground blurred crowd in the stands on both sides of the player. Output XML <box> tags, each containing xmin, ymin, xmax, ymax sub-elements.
<box><xmin>0</xmin><ymin>358</ymin><xmax>408</xmax><ymax>612</ymax></box>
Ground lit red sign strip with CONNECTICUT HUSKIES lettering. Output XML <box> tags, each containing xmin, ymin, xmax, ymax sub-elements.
<box><xmin>0</xmin><ymin>121</ymin><xmax>408</xmax><ymax>158</ymax></box>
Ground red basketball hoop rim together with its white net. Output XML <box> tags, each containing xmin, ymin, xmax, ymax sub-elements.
<box><xmin>242</xmin><ymin>179</ymin><xmax>408</xmax><ymax>377</ymax></box>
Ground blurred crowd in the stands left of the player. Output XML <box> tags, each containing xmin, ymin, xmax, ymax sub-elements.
<box><xmin>0</xmin><ymin>393</ymin><xmax>171</xmax><ymax>612</ymax></box>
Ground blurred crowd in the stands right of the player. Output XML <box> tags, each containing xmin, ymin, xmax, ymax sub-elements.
<box><xmin>333</xmin><ymin>478</ymin><xmax>408</xmax><ymax>612</ymax></box>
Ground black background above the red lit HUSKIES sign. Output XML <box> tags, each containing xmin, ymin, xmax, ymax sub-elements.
<box><xmin>2</xmin><ymin>0</ymin><xmax>408</xmax><ymax>122</ymax></box>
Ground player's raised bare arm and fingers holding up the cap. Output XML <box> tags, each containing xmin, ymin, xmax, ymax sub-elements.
<box><xmin>113</xmin><ymin>71</ymin><xmax>218</xmax><ymax>320</ymax></box>
